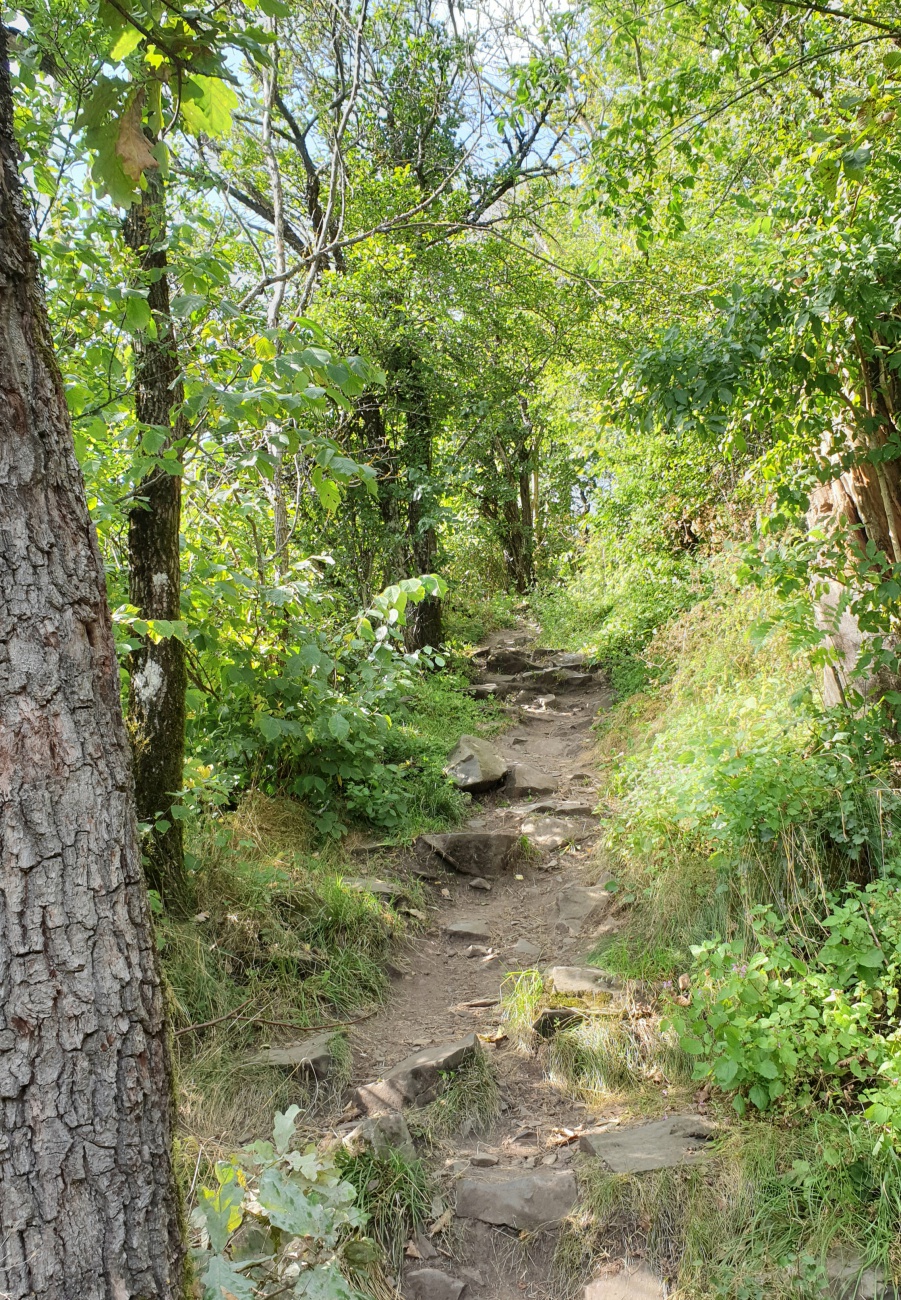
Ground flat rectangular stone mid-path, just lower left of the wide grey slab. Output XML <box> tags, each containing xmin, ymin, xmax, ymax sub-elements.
<box><xmin>456</xmin><ymin>1166</ymin><xmax>579</xmax><ymax>1231</ymax></box>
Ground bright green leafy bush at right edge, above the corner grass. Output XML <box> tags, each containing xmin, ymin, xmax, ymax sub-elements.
<box><xmin>670</xmin><ymin>878</ymin><xmax>901</xmax><ymax>1125</ymax></box>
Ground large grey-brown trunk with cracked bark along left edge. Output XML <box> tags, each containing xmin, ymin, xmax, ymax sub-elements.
<box><xmin>0</xmin><ymin>32</ymin><xmax>183</xmax><ymax>1300</ymax></box>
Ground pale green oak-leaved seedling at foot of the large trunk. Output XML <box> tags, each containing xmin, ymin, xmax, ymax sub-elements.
<box><xmin>191</xmin><ymin>1106</ymin><xmax>376</xmax><ymax>1300</ymax></box>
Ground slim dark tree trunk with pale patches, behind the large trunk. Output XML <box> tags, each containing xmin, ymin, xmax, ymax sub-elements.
<box><xmin>125</xmin><ymin>177</ymin><xmax>191</xmax><ymax>913</ymax></box>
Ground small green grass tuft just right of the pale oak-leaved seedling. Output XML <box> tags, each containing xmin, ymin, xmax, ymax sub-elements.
<box><xmin>335</xmin><ymin>1147</ymin><xmax>432</xmax><ymax>1273</ymax></box>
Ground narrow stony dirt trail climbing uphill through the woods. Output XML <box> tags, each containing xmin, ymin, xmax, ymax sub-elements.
<box><xmin>328</xmin><ymin>632</ymin><xmax>696</xmax><ymax>1300</ymax></box>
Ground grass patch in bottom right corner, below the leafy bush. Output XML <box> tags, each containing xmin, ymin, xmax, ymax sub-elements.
<box><xmin>556</xmin><ymin>1115</ymin><xmax>901</xmax><ymax>1300</ymax></box>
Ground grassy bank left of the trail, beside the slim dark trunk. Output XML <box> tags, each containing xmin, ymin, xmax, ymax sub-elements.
<box><xmin>164</xmin><ymin>794</ymin><xmax>415</xmax><ymax>1143</ymax></box>
